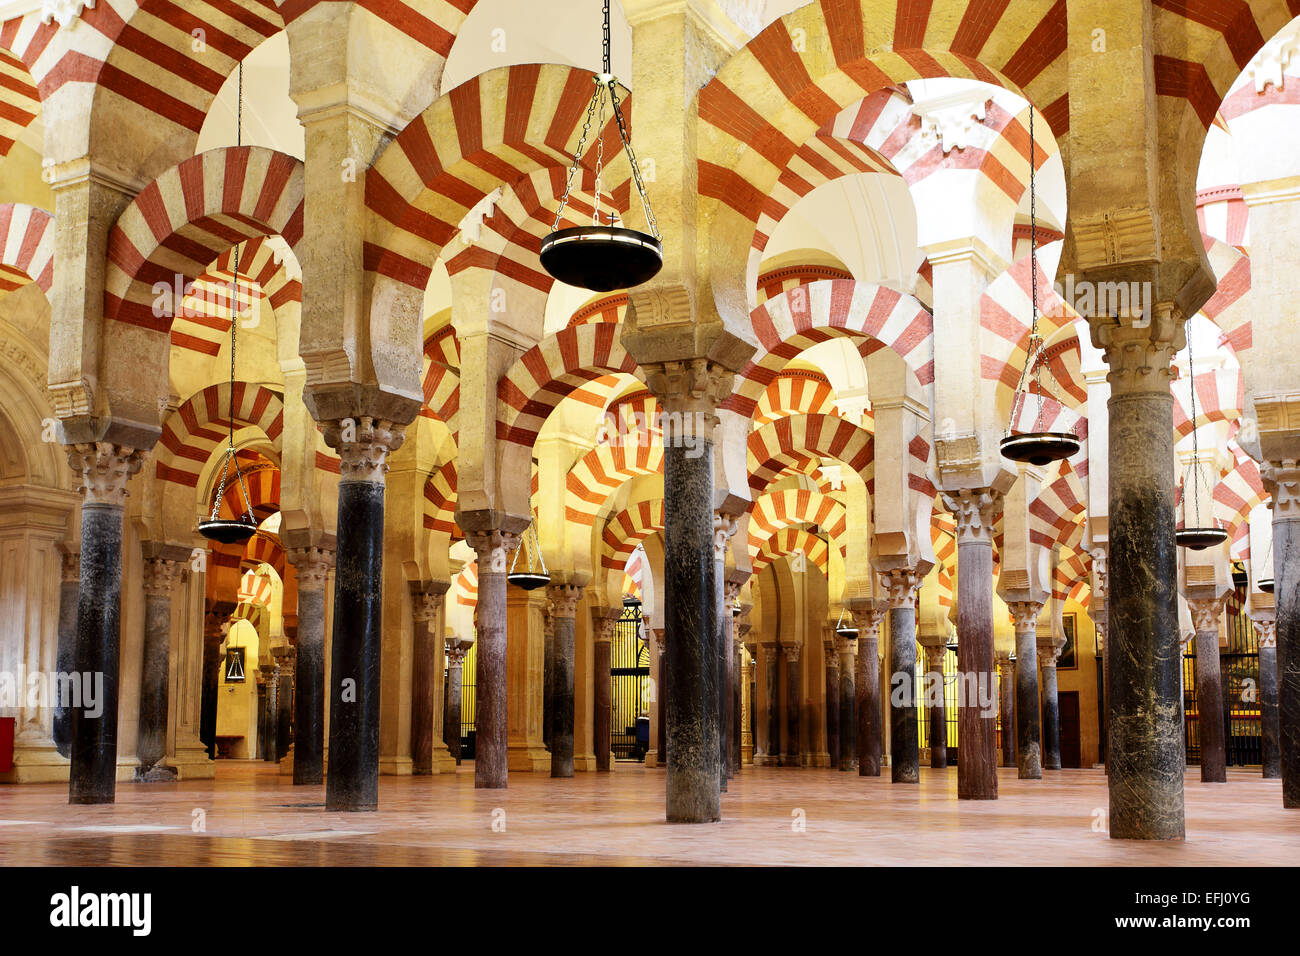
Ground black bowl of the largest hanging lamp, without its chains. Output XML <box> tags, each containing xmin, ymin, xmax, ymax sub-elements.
<box><xmin>541</xmin><ymin>226</ymin><xmax>663</xmax><ymax>293</ymax></box>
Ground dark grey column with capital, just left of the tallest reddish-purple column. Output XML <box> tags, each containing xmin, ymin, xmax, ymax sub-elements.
<box><xmin>883</xmin><ymin>568</ymin><xmax>925</xmax><ymax>783</ymax></box>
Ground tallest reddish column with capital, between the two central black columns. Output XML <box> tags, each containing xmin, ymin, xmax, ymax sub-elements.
<box><xmin>465</xmin><ymin>531</ymin><xmax>519</xmax><ymax>790</ymax></box>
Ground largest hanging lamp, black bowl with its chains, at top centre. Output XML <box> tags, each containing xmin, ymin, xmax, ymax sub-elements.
<box><xmin>541</xmin><ymin>0</ymin><xmax>663</xmax><ymax>293</ymax></box>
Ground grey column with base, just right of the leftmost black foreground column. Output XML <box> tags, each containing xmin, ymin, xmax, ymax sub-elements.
<box><xmin>135</xmin><ymin>554</ymin><xmax>190</xmax><ymax>783</ymax></box>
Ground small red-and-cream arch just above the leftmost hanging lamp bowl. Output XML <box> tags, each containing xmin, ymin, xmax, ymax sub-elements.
<box><xmin>155</xmin><ymin>381</ymin><xmax>285</xmax><ymax>488</ymax></box>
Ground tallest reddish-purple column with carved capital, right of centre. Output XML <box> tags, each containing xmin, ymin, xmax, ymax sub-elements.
<box><xmin>944</xmin><ymin>488</ymin><xmax>1002</xmax><ymax>800</ymax></box>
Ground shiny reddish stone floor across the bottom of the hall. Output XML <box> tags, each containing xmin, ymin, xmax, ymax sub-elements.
<box><xmin>0</xmin><ymin>761</ymin><xmax>1300</xmax><ymax>866</ymax></box>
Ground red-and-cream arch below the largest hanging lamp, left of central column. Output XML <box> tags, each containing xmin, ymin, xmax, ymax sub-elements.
<box><xmin>497</xmin><ymin>323</ymin><xmax>641</xmax><ymax>447</ymax></box>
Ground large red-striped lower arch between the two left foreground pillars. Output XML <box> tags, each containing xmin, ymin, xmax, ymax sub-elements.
<box><xmin>104</xmin><ymin>146</ymin><xmax>303</xmax><ymax>332</ymax></box>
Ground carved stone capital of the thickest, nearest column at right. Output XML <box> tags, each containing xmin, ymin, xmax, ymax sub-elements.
<box><xmin>1088</xmin><ymin>306</ymin><xmax>1187</xmax><ymax>397</ymax></box>
